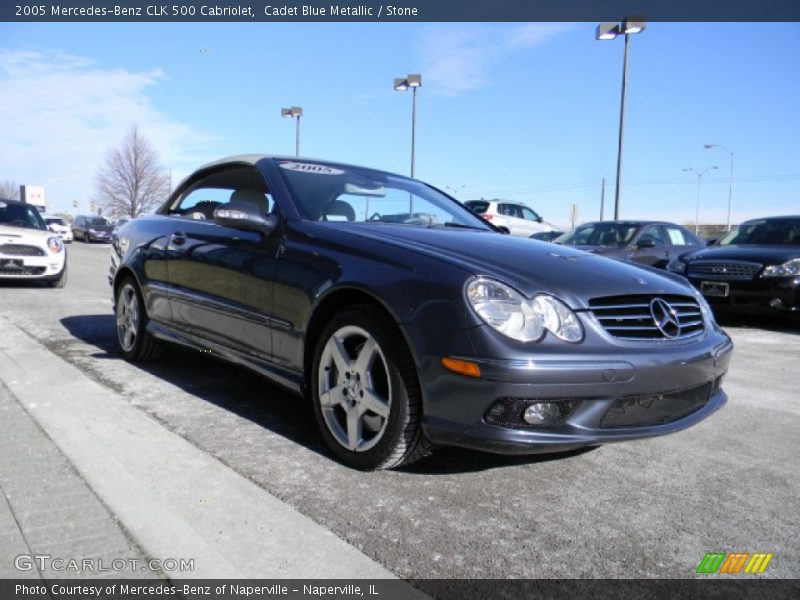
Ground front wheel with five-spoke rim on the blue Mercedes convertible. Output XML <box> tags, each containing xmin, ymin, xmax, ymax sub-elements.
<box><xmin>309</xmin><ymin>305</ymin><xmax>431</xmax><ymax>470</ymax></box>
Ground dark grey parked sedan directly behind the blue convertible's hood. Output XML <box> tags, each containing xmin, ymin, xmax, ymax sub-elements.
<box><xmin>555</xmin><ymin>221</ymin><xmax>706</xmax><ymax>269</ymax></box>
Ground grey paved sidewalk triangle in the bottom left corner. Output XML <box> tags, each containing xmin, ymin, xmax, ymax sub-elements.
<box><xmin>0</xmin><ymin>383</ymin><xmax>161</xmax><ymax>579</ymax></box>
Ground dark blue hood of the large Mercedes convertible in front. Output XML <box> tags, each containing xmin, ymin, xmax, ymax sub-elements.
<box><xmin>320</xmin><ymin>223</ymin><xmax>693</xmax><ymax>308</ymax></box>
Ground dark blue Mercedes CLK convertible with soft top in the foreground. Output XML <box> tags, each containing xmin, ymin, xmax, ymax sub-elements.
<box><xmin>110</xmin><ymin>156</ymin><xmax>732</xmax><ymax>469</ymax></box>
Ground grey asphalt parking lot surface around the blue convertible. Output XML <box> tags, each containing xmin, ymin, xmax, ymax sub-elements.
<box><xmin>0</xmin><ymin>243</ymin><xmax>800</xmax><ymax>578</ymax></box>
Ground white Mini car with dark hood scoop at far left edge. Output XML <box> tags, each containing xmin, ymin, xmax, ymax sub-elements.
<box><xmin>0</xmin><ymin>200</ymin><xmax>67</xmax><ymax>287</ymax></box>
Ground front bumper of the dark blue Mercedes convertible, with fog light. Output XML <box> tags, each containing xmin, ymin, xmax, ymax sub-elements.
<box><xmin>407</xmin><ymin>330</ymin><xmax>733</xmax><ymax>454</ymax></box>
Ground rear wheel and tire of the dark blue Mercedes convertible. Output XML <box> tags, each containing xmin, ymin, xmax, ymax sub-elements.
<box><xmin>114</xmin><ymin>277</ymin><xmax>163</xmax><ymax>361</ymax></box>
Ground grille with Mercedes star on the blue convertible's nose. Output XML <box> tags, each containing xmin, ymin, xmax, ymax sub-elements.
<box><xmin>589</xmin><ymin>294</ymin><xmax>705</xmax><ymax>340</ymax></box>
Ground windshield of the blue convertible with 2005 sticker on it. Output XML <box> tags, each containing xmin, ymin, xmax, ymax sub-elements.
<box><xmin>278</xmin><ymin>161</ymin><xmax>491</xmax><ymax>231</ymax></box>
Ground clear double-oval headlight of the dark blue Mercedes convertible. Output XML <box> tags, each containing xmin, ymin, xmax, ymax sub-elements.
<box><xmin>467</xmin><ymin>279</ymin><xmax>583</xmax><ymax>342</ymax></box>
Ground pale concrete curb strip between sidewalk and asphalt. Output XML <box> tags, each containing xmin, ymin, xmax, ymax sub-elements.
<box><xmin>0</xmin><ymin>317</ymin><xmax>400</xmax><ymax>592</ymax></box>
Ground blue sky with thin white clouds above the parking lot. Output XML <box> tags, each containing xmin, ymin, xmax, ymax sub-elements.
<box><xmin>0</xmin><ymin>23</ymin><xmax>800</xmax><ymax>225</ymax></box>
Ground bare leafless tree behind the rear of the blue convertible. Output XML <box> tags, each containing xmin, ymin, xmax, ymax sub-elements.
<box><xmin>97</xmin><ymin>125</ymin><xmax>170</xmax><ymax>217</ymax></box>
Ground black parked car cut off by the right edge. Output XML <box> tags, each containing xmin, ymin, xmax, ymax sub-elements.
<box><xmin>668</xmin><ymin>216</ymin><xmax>800</xmax><ymax>319</ymax></box>
